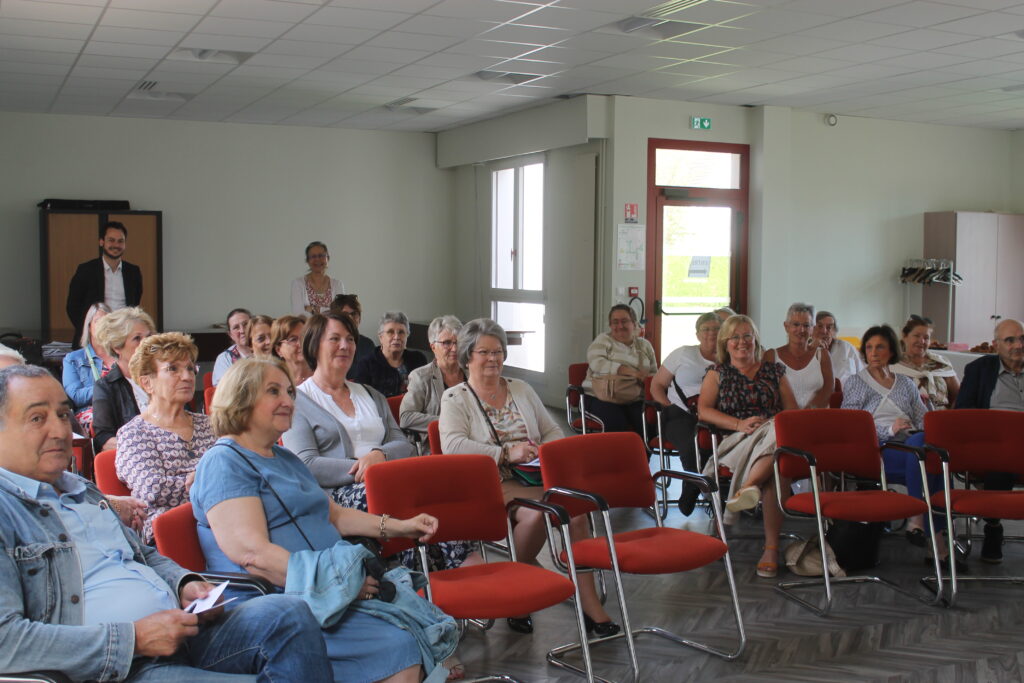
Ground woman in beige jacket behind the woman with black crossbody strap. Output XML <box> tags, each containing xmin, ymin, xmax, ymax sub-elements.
<box><xmin>398</xmin><ymin>315</ymin><xmax>466</xmax><ymax>443</ymax></box>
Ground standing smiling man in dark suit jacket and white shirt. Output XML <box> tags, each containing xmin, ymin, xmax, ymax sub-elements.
<box><xmin>68</xmin><ymin>220</ymin><xmax>142</xmax><ymax>348</ymax></box>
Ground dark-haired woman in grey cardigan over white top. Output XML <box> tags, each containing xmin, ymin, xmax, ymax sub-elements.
<box><xmin>283</xmin><ymin>313</ymin><xmax>416</xmax><ymax>510</ymax></box>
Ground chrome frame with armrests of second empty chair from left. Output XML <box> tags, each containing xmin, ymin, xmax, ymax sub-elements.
<box><xmin>544</xmin><ymin>470</ymin><xmax>746</xmax><ymax>683</ymax></box>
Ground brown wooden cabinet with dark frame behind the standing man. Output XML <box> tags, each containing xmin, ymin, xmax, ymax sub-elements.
<box><xmin>39</xmin><ymin>209</ymin><xmax>164</xmax><ymax>343</ymax></box>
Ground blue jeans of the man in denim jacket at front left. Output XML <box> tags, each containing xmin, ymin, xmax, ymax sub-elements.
<box><xmin>126</xmin><ymin>595</ymin><xmax>333</xmax><ymax>683</ymax></box>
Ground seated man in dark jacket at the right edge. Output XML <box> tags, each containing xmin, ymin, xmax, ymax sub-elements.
<box><xmin>956</xmin><ymin>319</ymin><xmax>1024</xmax><ymax>564</ymax></box>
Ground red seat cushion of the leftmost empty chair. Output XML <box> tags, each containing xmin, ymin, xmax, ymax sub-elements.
<box><xmin>430</xmin><ymin>562</ymin><xmax>575</xmax><ymax>618</ymax></box>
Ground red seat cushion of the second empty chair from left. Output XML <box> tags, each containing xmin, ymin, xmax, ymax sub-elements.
<box><xmin>562</xmin><ymin>527</ymin><xmax>728</xmax><ymax>573</ymax></box>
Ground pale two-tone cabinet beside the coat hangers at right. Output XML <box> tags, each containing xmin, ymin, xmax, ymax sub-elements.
<box><xmin>922</xmin><ymin>211</ymin><xmax>1024</xmax><ymax>345</ymax></box>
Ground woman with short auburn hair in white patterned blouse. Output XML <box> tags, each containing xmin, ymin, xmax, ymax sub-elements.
<box><xmin>116</xmin><ymin>332</ymin><xmax>217</xmax><ymax>543</ymax></box>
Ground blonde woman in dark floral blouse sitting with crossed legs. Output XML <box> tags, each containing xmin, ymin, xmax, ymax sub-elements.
<box><xmin>697</xmin><ymin>315</ymin><xmax>797</xmax><ymax>578</ymax></box>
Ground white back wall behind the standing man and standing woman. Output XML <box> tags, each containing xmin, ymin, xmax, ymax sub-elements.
<box><xmin>0</xmin><ymin>109</ymin><xmax>456</xmax><ymax>333</ymax></box>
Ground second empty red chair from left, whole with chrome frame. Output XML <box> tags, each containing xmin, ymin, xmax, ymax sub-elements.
<box><xmin>541</xmin><ymin>432</ymin><xmax>746</xmax><ymax>676</ymax></box>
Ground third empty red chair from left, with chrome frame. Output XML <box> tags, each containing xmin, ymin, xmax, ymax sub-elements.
<box><xmin>774</xmin><ymin>410</ymin><xmax>939</xmax><ymax>616</ymax></box>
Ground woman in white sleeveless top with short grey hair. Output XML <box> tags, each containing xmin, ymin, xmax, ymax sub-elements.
<box><xmin>765</xmin><ymin>303</ymin><xmax>836</xmax><ymax>408</ymax></box>
